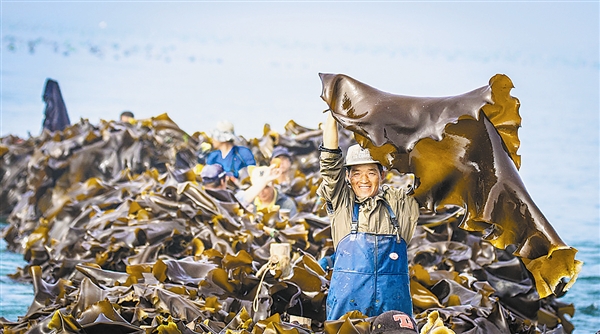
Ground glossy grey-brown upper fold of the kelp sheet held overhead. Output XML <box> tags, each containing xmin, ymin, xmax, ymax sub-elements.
<box><xmin>320</xmin><ymin>74</ymin><xmax>492</xmax><ymax>152</ymax></box>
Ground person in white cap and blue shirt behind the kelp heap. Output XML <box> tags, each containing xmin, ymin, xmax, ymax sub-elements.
<box><xmin>206</xmin><ymin>121</ymin><xmax>256</xmax><ymax>179</ymax></box>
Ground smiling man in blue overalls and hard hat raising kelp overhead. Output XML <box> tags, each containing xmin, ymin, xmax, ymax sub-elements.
<box><xmin>318</xmin><ymin>112</ymin><xmax>419</xmax><ymax>320</ymax></box>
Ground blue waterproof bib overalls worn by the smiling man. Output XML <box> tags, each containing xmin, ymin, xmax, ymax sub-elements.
<box><xmin>327</xmin><ymin>201</ymin><xmax>412</xmax><ymax>320</ymax></box>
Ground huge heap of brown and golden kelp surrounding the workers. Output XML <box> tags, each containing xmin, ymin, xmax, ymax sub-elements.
<box><xmin>0</xmin><ymin>115</ymin><xmax>574</xmax><ymax>334</ymax></box>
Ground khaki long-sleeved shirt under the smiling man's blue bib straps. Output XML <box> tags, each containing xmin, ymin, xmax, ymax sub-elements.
<box><xmin>317</xmin><ymin>152</ymin><xmax>419</xmax><ymax>247</ymax></box>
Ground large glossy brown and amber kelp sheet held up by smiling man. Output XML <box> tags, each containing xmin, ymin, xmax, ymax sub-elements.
<box><xmin>320</xmin><ymin>74</ymin><xmax>582</xmax><ymax>298</ymax></box>
